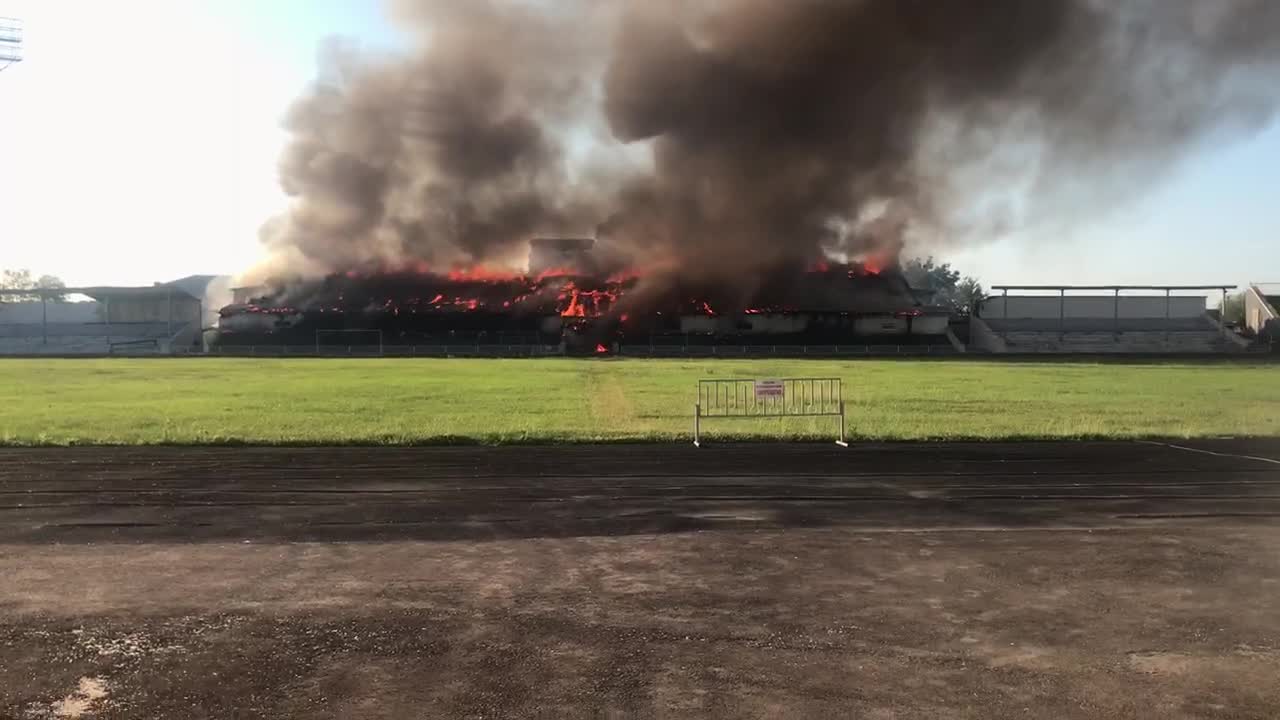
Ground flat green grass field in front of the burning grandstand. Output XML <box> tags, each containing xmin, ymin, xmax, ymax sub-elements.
<box><xmin>0</xmin><ymin>359</ymin><xmax>1280</xmax><ymax>445</ymax></box>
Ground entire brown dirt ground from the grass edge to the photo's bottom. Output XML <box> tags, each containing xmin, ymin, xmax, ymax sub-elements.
<box><xmin>0</xmin><ymin>441</ymin><xmax>1280</xmax><ymax>719</ymax></box>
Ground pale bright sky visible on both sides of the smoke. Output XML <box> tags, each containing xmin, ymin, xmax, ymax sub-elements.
<box><xmin>0</xmin><ymin>0</ymin><xmax>1280</xmax><ymax>286</ymax></box>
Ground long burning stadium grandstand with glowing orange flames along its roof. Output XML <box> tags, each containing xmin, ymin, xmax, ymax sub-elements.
<box><xmin>216</xmin><ymin>241</ymin><xmax>948</xmax><ymax>354</ymax></box>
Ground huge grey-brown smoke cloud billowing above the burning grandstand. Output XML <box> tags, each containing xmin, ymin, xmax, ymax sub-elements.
<box><xmin>249</xmin><ymin>0</ymin><xmax>1280</xmax><ymax>284</ymax></box>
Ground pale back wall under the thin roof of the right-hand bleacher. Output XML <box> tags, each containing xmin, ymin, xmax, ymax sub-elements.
<box><xmin>980</xmin><ymin>295</ymin><xmax>1206</xmax><ymax>319</ymax></box>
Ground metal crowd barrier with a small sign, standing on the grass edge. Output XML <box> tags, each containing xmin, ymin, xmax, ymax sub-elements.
<box><xmin>694</xmin><ymin>378</ymin><xmax>849</xmax><ymax>447</ymax></box>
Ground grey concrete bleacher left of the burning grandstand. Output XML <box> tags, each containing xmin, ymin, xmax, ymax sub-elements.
<box><xmin>0</xmin><ymin>323</ymin><xmax>176</xmax><ymax>355</ymax></box>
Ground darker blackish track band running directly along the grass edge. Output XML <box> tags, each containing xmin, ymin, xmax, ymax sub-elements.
<box><xmin>0</xmin><ymin>441</ymin><xmax>1280</xmax><ymax>542</ymax></box>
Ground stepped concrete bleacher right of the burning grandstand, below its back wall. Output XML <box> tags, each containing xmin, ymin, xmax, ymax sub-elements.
<box><xmin>983</xmin><ymin>315</ymin><xmax>1240</xmax><ymax>354</ymax></box>
